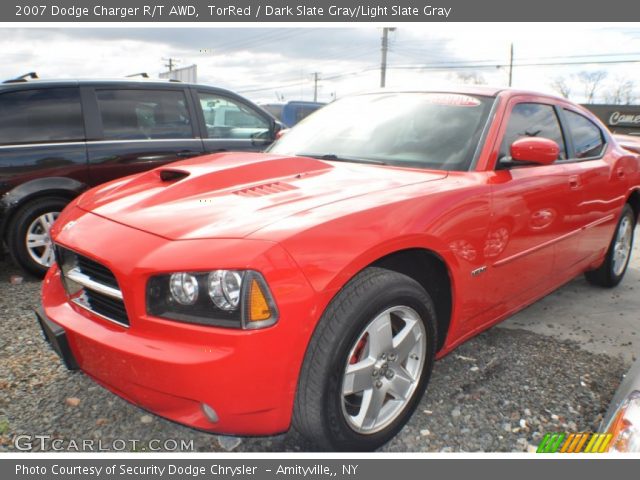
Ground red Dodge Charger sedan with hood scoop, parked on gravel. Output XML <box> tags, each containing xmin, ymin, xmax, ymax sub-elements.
<box><xmin>38</xmin><ymin>87</ymin><xmax>640</xmax><ymax>450</ymax></box>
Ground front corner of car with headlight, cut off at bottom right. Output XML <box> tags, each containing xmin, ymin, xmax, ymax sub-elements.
<box><xmin>599</xmin><ymin>359</ymin><xmax>640</xmax><ymax>453</ymax></box>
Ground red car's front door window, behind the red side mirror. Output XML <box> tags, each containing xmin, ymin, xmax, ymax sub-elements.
<box><xmin>498</xmin><ymin>103</ymin><xmax>567</xmax><ymax>162</ymax></box>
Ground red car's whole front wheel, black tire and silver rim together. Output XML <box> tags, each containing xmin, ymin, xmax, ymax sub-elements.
<box><xmin>293</xmin><ymin>268</ymin><xmax>437</xmax><ymax>451</ymax></box>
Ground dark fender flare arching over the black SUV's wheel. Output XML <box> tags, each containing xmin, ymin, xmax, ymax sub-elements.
<box><xmin>0</xmin><ymin>177</ymin><xmax>88</xmax><ymax>239</ymax></box>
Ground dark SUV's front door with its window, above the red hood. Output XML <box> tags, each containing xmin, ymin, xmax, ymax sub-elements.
<box><xmin>193</xmin><ymin>88</ymin><xmax>275</xmax><ymax>153</ymax></box>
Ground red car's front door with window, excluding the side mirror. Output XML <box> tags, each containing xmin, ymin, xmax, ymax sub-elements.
<box><xmin>485</xmin><ymin>97</ymin><xmax>579</xmax><ymax>311</ymax></box>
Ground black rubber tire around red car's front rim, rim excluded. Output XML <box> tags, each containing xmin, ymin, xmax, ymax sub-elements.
<box><xmin>293</xmin><ymin>268</ymin><xmax>437</xmax><ymax>451</ymax></box>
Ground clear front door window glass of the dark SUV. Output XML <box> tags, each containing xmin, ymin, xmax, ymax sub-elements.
<box><xmin>198</xmin><ymin>92</ymin><xmax>270</xmax><ymax>139</ymax></box>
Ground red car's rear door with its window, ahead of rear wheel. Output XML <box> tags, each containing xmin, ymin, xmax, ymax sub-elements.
<box><xmin>559</xmin><ymin>108</ymin><xmax>627</xmax><ymax>268</ymax></box>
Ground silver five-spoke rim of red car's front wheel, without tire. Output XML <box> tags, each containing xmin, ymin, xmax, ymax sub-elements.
<box><xmin>341</xmin><ymin>306</ymin><xmax>427</xmax><ymax>434</ymax></box>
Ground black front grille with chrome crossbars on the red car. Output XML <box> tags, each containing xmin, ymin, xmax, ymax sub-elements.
<box><xmin>56</xmin><ymin>246</ymin><xmax>129</xmax><ymax>327</ymax></box>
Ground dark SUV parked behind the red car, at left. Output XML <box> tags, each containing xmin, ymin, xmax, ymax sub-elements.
<box><xmin>0</xmin><ymin>78</ymin><xmax>281</xmax><ymax>276</ymax></box>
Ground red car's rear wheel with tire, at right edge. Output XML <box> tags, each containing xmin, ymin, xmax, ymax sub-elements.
<box><xmin>585</xmin><ymin>203</ymin><xmax>636</xmax><ymax>288</ymax></box>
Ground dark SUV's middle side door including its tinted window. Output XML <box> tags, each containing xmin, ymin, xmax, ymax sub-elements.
<box><xmin>83</xmin><ymin>84</ymin><xmax>204</xmax><ymax>185</ymax></box>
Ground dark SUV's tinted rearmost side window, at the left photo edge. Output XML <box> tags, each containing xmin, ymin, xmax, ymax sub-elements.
<box><xmin>0</xmin><ymin>88</ymin><xmax>85</xmax><ymax>145</ymax></box>
